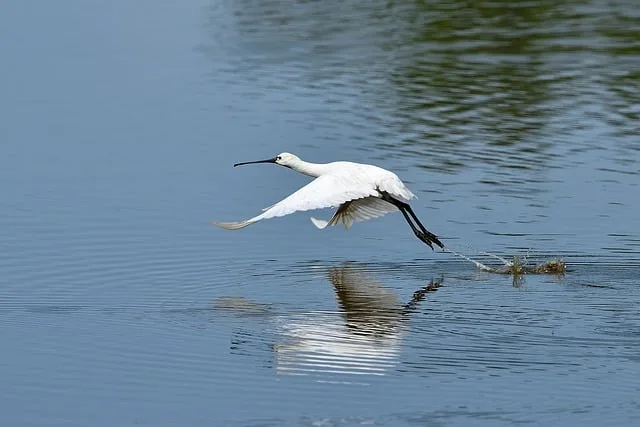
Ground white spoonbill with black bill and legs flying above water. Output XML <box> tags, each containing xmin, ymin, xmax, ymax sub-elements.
<box><xmin>213</xmin><ymin>153</ymin><xmax>444</xmax><ymax>249</ymax></box>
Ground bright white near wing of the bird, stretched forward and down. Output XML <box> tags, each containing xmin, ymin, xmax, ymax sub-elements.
<box><xmin>213</xmin><ymin>174</ymin><xmax>379</xmax><ymax>230</ymax></box>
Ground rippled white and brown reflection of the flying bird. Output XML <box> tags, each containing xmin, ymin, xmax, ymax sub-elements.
<box><xmin>276</xmin><ymin>265</ymin><xmax>441</xmax><ymax>375</ymax></box>
